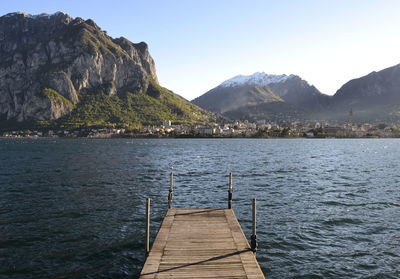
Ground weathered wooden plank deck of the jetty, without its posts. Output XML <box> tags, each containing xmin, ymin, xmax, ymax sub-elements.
<box><xmin>139</xmin><ymin>208</ymin><xmax>264</xmax><ymax>279</ymax></box>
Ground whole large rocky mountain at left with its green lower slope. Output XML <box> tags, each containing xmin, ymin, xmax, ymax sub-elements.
<box><xmin>0</xmin><ymin>12</ymin><xmax>212</xmax><ymax>128</ymax></box>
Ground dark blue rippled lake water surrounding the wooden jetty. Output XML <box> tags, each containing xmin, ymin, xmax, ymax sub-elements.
<box><xmin>0</xmin><ymin>139</ymin><xmax>400</xmax><ymax>279</ymax></box>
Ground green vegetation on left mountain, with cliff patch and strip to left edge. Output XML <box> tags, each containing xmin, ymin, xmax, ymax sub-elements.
<box><xmin>0</xmin><ymin>80</ymin><xmax>212</xmax><ymax>131</ymax></box>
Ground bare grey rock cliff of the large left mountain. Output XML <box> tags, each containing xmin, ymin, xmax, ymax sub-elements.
<box><xmin>0</xmin><ymin>12</ymin><xmax>158</xmax><ymax>121</ymax></box>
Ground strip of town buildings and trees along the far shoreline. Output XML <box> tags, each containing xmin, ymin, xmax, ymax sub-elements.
<box><xmin>0</xmin><ymin>120</ymin><xmax>400</xmax><ymax>138</ymax></box>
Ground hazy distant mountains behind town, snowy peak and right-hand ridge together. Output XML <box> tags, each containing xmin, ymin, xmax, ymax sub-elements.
<box><xmin>192</xmin><ymin>65</ymin><xmax>400</xmax><ymax>122</ymax></box>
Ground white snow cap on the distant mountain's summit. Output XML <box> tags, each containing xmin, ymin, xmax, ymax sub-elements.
<box><xmin>220</xmin><ymin>72</ymin><xmax>294</xmax><ymax>87</ymax></box>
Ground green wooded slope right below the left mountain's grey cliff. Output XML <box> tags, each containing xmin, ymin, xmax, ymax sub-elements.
<box><xmin>58</xmin><ymin>81</ymin><xmax>213</xmax><ymax>128</ymax></box>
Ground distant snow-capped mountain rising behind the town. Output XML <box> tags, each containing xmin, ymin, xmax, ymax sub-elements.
<box><xmin>192</xmin><ymin>72</ymin><xmax>331</xmax><ymax>120</ymax></box>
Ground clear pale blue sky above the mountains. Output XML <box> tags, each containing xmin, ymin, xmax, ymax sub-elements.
<box><xmin>0</xmin><ymin>0</ymin><xmax>400</xmax><ymax>99</ymax></box>
